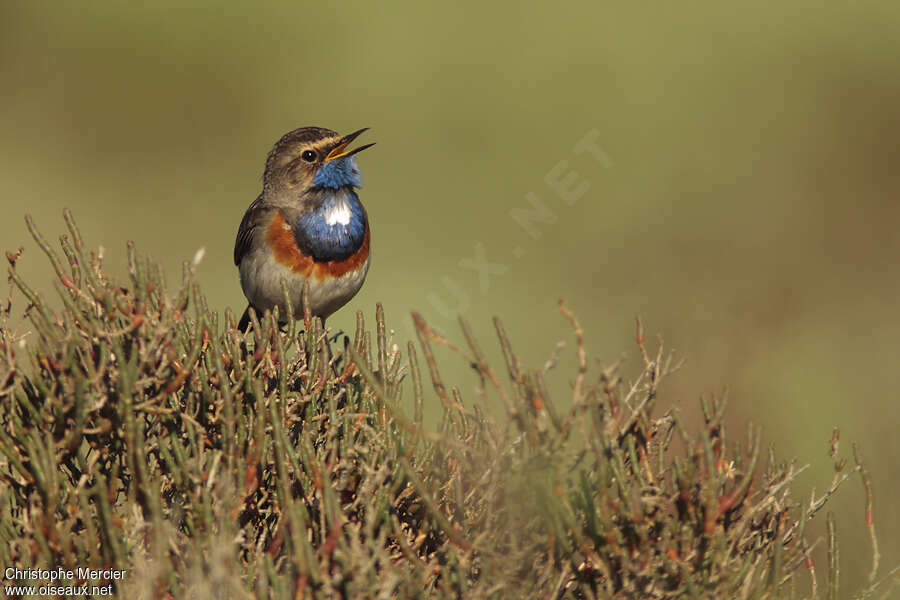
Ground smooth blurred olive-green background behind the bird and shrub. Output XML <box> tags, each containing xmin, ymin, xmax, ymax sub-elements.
<box><xmin>0</xmin><ymin>1</ymin><xmax>900</xmax><ymax>591</ymax></box>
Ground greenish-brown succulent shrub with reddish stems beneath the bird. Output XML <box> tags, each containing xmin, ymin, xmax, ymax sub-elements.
<box><xmin>0</xmin><ymin>213</ymin><xmax>877</xmax><ymax>598</ymax></box>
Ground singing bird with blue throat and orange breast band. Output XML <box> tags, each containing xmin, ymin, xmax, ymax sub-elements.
<box><xmin>234</xmin><ymin>127</ymin><xmax>374</xmax><ymax>331</ymax></box>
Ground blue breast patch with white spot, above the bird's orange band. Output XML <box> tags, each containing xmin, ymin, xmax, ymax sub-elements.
<box><xmin>292</xmin><ymin>190</ymin><xmax>366</xmax><ymax>262</ymax></box>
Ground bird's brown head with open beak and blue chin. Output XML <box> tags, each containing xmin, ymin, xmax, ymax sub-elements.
<box><xmin>263</xmin><ymin>127</ymin><xmax>375</xmax><ymax>199</ymax></box>
